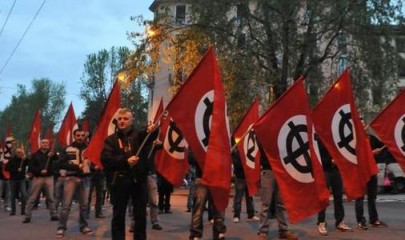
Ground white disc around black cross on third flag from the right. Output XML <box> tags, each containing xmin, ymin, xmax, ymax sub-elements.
<box><xmin>277</xmin><ymin>115</ymin><xmax>314</xmax><ymax>183</ymax></box>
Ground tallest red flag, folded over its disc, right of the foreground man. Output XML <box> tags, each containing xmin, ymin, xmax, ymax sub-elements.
<box><xmin>167</xmin><ymin>49</ymin><xmax>231</xmax><ymax>210</ymax></box>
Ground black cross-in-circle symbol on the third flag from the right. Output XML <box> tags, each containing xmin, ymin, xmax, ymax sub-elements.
<box><xmin>283</xmin><ymin>121</ymin><xmax>312</xmax><ymax>174</ymax></box>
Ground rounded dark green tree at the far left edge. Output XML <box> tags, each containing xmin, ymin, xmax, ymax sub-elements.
<box><xmin>0</xmin><ymin>78</ymin><xmax>66</xmax><ymax>143</ymax></box>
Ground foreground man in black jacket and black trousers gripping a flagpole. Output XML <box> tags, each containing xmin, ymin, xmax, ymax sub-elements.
<box><xmin>101</xmin><ymin>108</ymin><xmax>157</xmax><ymax>240</ymax></box>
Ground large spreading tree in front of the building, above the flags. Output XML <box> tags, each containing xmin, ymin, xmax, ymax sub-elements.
<box><xmin>133</xmin><ymin>0</ymin><xmax>404</xmax><ymax>128</ymax></box>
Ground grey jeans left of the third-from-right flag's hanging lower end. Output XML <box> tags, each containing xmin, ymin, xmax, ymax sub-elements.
<box><xmin>258</xmin><ymin>170</ymin><xmax>288</xmax><ymax>236</ymax></box>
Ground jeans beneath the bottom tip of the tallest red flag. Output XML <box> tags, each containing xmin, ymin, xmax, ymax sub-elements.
<box><xmin>190</xmin><ymin>183</ymin><xmax>226</xmax><ymax>240</ymax></box>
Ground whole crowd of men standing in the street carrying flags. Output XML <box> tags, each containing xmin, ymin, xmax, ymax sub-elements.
<box><xmin>0</xmin><ymin>108</ymin><xmax>387</xmax><ymax>240</ymax></box>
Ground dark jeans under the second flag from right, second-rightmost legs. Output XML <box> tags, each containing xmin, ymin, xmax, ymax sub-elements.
<box><xmin>318</xmin><ymin>167</ymin><xmax>345</xmax><ymax>226</ymax></box>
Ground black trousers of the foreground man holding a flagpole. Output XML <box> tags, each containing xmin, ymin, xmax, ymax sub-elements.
<box><xmin>111</xmin><ymin>176</ymin><xmax>148</xmax><ymax>240</ymax></box>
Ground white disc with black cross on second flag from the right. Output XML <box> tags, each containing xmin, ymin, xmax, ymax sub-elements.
<box><xmin>331</xmin><ymin>104</ymin><xmax>357</xmax><ymax>164</ymax></box>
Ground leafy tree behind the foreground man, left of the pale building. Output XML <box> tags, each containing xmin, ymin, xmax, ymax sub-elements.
<box><xmin>80</xmin><ymin>47</ymin><xmax>147</xmax><ymax>130</ymax></box>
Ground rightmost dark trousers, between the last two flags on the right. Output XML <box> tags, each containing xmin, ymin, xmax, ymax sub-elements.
<box><xmin>354</xmin><ymin>175</ymin><xmax>378</xmax><ymax>223</ymax></box>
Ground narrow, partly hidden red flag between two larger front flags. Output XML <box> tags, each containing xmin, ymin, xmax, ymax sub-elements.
<box><xmin>233</xmin><ymin>99</ymin><xmax>260</xmax><ymax>196</ymax></box>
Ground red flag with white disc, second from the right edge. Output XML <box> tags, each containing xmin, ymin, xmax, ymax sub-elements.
<box><xmin>313</xmin><ymin>70</ymin><xmax>378</xmax><ymax>199</ymax></box>
